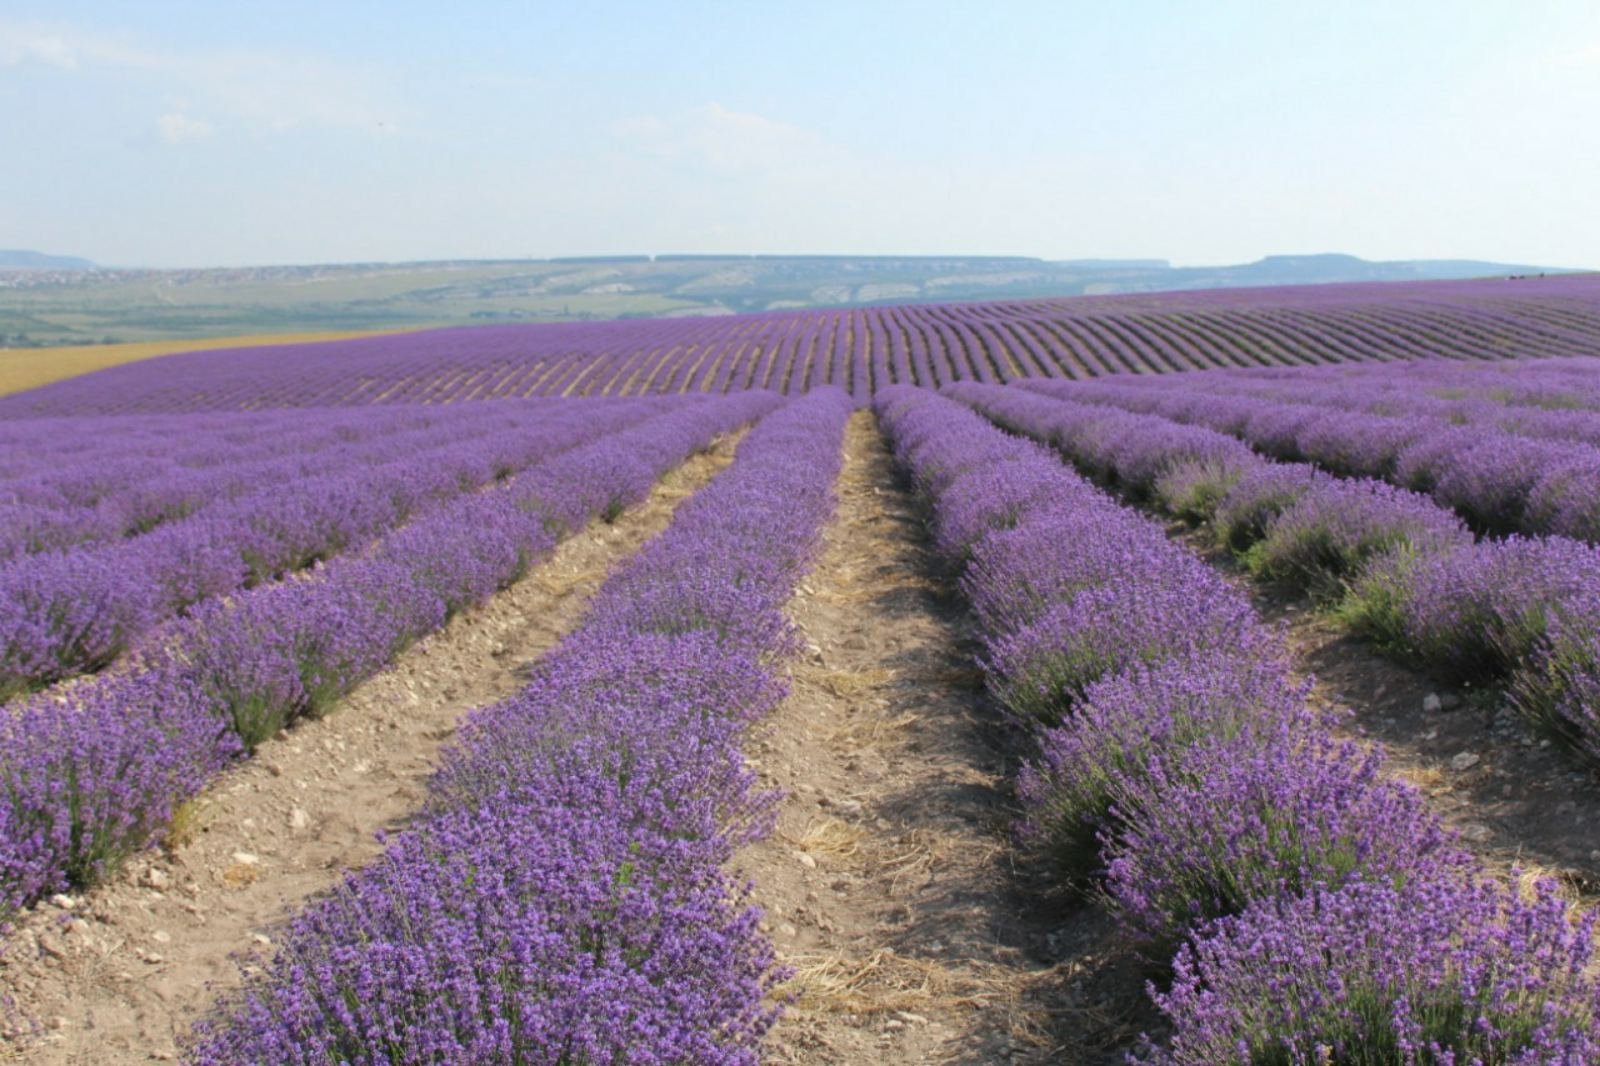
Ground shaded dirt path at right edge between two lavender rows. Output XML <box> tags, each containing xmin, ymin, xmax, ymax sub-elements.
<box><xmin>1170</xmin><ymin>527</ymin><xmax>1600</xmax><ymax>903</ymax></box>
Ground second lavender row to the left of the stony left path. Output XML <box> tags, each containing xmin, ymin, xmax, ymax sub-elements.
<box><xmin>0</xmin><ymin>400</ymin><xmax>670</xmax><ymax>699</ymax></box>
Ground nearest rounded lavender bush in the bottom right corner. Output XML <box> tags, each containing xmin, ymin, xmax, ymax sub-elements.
<box><xmin>1147</xmin><ymin>879</ymin><xmax>1600</xmax><ymax>1066</ymax></box>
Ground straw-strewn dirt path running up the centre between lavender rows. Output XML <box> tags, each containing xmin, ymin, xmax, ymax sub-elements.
<box><xmin>738</xmin><ymin>413</ymin><xmax>1138</xmax><ymax>1066</ymax></box>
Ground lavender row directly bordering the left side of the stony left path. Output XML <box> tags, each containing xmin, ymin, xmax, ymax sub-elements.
<box><xmin>0</xmin><ymin>392</ymin><xmax>779</xmax><ymax>916</ymax></box>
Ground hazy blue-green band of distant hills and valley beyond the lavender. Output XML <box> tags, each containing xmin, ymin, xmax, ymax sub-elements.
<box><xmin>0</xmin><ymin>251</ymin><xmax>1558</xmax><ymax>347</ymax></box>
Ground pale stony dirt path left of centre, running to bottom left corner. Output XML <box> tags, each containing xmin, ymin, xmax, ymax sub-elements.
<box><xmin>0</xmin><ymin>437</ymin><xmax>734</xmax><ymax>1066</ymax></box>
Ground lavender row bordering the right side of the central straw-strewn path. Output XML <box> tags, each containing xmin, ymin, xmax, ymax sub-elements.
<box><xmin>878</xmin><ymin>391</ymin><xmax>1600</xmax><ymax>1066</ymax></box>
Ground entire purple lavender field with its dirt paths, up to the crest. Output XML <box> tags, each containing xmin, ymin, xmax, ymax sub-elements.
<box><xmin>0</xmin><ymin>275</ymin><xmax>1600</xmax><ymax>1066</ymax></box>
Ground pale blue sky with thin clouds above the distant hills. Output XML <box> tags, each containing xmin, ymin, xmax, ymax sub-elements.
<box><xmin>0</xmin><ymin>0</ymin><xmax>1600</xmax><ymax>267</ymax></box>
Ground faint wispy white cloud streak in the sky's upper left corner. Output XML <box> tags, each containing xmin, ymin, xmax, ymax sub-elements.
<box><xmin>0</xmin><ymin>21</ymin><xmax>403</xmax><ymax>136</ymax></box>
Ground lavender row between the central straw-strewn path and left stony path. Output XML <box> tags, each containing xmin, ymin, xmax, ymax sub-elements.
<box><xmin>190</xmin><ymin>391</ymin><xmax>848</xmax><ymax>1066</ymax></box>
